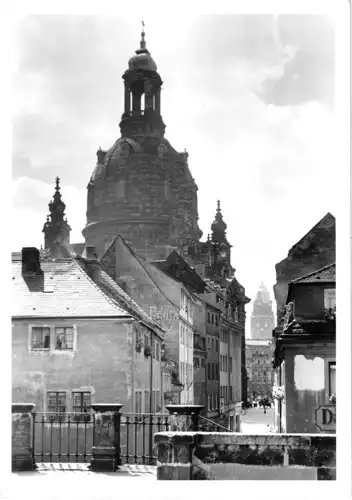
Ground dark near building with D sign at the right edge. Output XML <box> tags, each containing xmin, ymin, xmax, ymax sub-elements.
<box><xmin>274</xmin><ymin>263</ymin><xmax>336</xmax><ymax>433</ymax></box>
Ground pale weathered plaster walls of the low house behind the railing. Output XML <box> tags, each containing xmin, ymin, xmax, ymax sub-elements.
<box><xmin>12</xmin><ymin>319</ymin><xmax>160</xmax><ymax>412</ymax></box>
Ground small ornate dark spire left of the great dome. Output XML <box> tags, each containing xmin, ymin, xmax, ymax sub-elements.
<box><xmin>43</xmin><ymin>177</ymin><xmax>71</xmax><ymax>253</ymax></box>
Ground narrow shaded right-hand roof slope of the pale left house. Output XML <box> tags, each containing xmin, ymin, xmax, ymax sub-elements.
<box><xmin>99</xmin><ymin>271</ymin><xmax>162</xmax><ymax>336</ymax></box>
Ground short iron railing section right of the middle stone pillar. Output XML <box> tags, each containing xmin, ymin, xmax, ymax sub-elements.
<box><xmin>120</xmin><ymin>413</ymin><xmax>170</xmax><ymax>465</ymax></box>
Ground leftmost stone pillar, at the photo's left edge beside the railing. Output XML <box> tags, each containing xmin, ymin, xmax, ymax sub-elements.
<box><xmin>12</xmin><ymin>403</ymin><xmax>35</xmax><ymax>471</ymax></box>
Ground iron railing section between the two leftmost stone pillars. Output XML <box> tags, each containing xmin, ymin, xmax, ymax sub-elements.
<box><xmin>33</xmin><ymin>412</ymin><xmax>94</xmax><ymax>463</ymax></box>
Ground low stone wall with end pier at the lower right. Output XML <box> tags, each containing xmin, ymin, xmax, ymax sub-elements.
<box><xmin>154</xmin><ymin>432</ymin><xmax>336</xmax><ymax>480</ymax></box>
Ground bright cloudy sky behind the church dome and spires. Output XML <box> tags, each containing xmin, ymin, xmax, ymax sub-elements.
<box><xmin>11</xmin><ymin>14</ymin><xmax>339</xmax><ymax>328</ymax></box>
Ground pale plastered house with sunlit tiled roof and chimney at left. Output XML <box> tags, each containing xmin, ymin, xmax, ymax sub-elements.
<box><xmin>12</xmin><ymin>248</ymin><xmax>163</xmax><ymax>414</ymax></box>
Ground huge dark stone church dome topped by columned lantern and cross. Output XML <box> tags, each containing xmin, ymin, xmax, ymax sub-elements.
<box><xmin>83</xmin><ymin>28</ymin><xmax>202</xmax><ymax>260</ymax></box>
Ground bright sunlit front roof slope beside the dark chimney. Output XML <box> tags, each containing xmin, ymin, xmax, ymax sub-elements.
<box><xmin>12</xmin><ymin>253</ymin><xmax>131</xmax><ymax>318</ymax></box>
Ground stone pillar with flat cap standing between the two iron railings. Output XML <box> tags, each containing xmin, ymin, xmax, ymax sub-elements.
<box><xmin>90</xmin><ymin>404</ymin><xmax>123</xmax><ymax>472</ymax></box>
